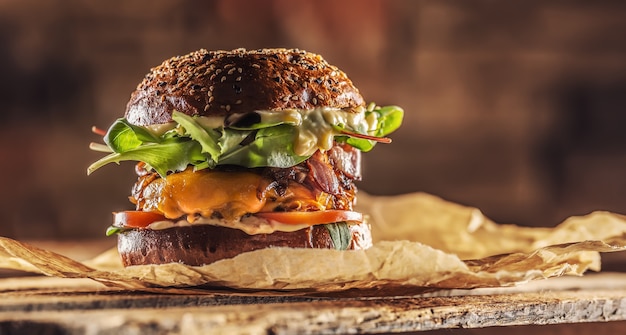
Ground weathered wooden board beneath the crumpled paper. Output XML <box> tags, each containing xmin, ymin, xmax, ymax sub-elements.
<box><xmin>0</xmin><ymin>273</ymin><xmax>626</xmax><ymax>334</ymax></box>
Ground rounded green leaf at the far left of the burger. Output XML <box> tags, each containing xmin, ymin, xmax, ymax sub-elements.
<box><xmin>104</xmin><ymin>119</ymin><xmax>160</xmax><ymax>152</ymax></box>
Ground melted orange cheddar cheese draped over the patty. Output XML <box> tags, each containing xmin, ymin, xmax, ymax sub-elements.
<box><xmin>141</xmin><ymin>169</ymin><xmax>328</xmax><ymax>222</ymax></box>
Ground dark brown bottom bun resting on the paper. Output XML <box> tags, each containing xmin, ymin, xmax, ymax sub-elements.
<box><xmin>118</xmin><ymin>223</ymin><xmax>372</xmax><ymax>266</ymax></box>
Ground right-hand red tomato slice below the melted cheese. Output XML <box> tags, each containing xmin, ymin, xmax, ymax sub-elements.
<box><xmin>254</xmin><ymin>209</ymin><xmax>363</xmax><ymax>225</ymax></box>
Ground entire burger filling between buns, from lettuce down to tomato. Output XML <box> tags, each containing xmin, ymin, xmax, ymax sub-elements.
<box><xmin>88</xmin><ymin>104</ymin><xmax>403</xmax><ymax>247</ymax></box>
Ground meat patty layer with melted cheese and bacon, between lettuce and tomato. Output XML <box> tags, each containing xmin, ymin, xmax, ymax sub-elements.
<box><xmin>130</xmin><ymin>145</ymin><xmax>360</xmax><ymax>225</ymax></box>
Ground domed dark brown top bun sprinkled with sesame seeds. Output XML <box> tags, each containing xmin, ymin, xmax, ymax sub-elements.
<box><xmin>125</xmin><ymin>49</ymin><xmax>365</xmax><ymax>126</ymax></box>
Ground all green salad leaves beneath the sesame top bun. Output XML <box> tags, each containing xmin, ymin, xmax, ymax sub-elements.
<box><xmin>87</xmin><ymin>105</ymin><xmax>403</xmax><ymax>176</ymax></box>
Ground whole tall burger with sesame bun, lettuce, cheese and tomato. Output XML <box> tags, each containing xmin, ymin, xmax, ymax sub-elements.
<box><xmin>87</xmin><ymin>49</ymin><xmax>403</xmax><ymax>266</ymax></box>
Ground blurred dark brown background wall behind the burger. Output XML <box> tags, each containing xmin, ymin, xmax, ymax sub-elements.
<box><xmin>0</xmin><ymin>0</ymin><xmax>626</xmax><ymax>239</ymax></box>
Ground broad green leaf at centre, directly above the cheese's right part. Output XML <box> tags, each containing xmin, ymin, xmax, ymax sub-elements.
<box><xmin>219</xmin><ymin>125</ymin><xmax>308</xmax><ymax>168</ymax></box>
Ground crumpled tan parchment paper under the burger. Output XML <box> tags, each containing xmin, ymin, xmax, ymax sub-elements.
<box><xmin>0</xmin><ymin>192</ymin><xmax>626</xmax><ymax>294</ymax></box>
